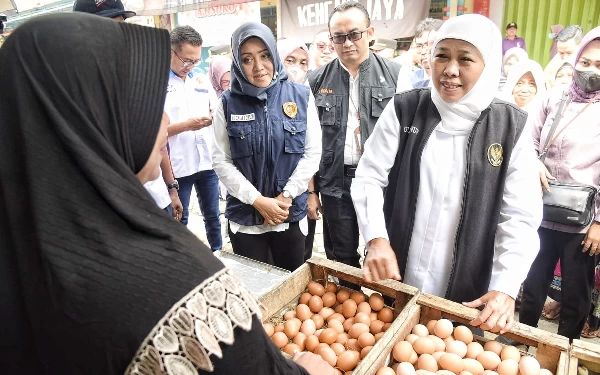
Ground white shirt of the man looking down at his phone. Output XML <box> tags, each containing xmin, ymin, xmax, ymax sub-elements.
<box><xmin>165</xmin><ymin>71</ymin><xmax>218</xmax><ymax>178</ymax></box>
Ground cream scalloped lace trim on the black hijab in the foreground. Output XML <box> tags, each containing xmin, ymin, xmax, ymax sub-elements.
<box><xmin>125</xmin><ymin>268</ymin><xmax>261</xmax><ymax>375</ymax></box>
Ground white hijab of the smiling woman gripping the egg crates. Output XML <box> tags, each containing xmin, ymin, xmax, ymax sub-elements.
<box><xmin>431</xmin><ymin>14</ymin><xmax>502</xmax><ymax>132</ymax></box>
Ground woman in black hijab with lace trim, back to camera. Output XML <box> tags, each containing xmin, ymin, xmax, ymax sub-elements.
<box><xmin>0</xmin><ymin>14</ymin><xmax>333</xmax><ymax>375</ymax></box>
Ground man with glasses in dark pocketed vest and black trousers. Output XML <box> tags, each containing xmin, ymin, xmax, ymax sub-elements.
<box><xmin>308</xmin><ymin>1</ymin><xmax>412</xmax><ymax>288</ymax></box>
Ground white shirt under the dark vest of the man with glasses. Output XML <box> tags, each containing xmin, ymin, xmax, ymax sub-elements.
<box><xmin>340</xmin><ymin>60</ymin><xmax>413</xmax><ymax>165</ymax></box>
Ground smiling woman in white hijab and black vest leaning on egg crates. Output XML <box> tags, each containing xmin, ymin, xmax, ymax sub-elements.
<box><xmin>351</xmin><ymin>15</ymin><xmax>542</xmax><ymax>333</ymax></box>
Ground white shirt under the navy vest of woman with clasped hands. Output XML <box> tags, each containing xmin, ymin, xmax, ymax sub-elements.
<box><xmin>212</xmin><ymin>93</ymin><xmax>322</xmax><ymax>235</ymax></box>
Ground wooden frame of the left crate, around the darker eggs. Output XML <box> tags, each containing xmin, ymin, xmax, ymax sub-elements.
<box><xmin>259</xmin><ymin>257</ymin><xmax>419</xmax><ymax>375</ymax></box>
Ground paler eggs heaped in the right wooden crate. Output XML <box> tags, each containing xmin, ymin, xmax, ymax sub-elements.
<box><xmin>376</xmin><ymin>319</ymin><xmax>552</xmax><ymax>375</ymax></box>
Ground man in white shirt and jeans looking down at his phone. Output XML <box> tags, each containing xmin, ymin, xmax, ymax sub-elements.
<box><xmin>165</xmin><ymin>26</ymin><xmax>223</xmax><ymax>251</ymax></box>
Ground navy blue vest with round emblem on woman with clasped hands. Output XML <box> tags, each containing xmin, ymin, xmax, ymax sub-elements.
<box><xmin>221</xmin><ymin>81</ymin><xmax>309</xmax><ymax>226</ymax></box>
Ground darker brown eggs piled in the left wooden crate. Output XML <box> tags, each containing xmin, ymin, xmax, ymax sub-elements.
<box><xmin>263</xmin><ymin>281</ymin><xmax>394</xmax><ymax>375</ymax></box>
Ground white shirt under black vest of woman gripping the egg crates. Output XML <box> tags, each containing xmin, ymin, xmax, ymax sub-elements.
<box><xmin>351</xmin><ymin>102</ymin><xmax>542</xmax><ymax>298</ymax></box>
